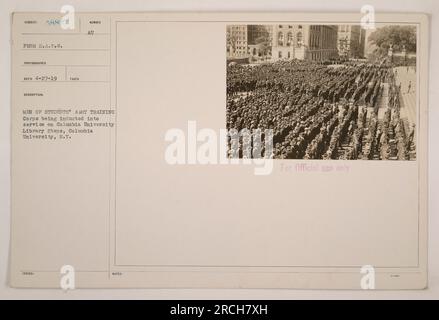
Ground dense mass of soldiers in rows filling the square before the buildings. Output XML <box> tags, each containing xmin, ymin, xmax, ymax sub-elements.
<box><xmin>227</xmin><ymin>60</ymin><xmax>415</xmax><ymax>160</ymax></box>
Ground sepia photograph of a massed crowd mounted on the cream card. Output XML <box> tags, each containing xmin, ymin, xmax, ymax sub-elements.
<box><xmin>226</xmin><ymin>22</ymin><xmax>417</xmax><ymax>161</ymax></box>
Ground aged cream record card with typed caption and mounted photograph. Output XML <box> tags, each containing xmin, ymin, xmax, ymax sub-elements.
<box><xmin>10</xmin><ymin>13</ymin><xmax>428</xmax><ymax>289</ymax></box>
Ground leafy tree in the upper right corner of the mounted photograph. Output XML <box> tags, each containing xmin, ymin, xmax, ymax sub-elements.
<box><xmin>369</xmin><ymin>26</ymin><xmax>416</xmax><ymax>55</ymax></box>
